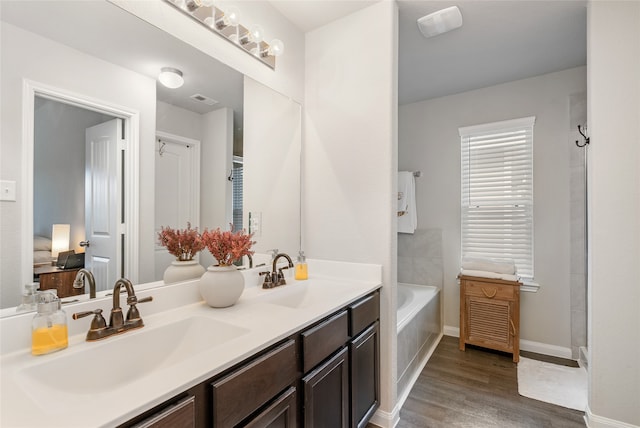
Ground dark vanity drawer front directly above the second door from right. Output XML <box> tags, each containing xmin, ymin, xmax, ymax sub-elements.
<box><xmin>300</xmin><ymin>310</ymin><xmax>349</xmax><ymax>373</ymax></box>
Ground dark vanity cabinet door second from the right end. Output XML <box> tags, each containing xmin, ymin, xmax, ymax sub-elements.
<box><xmin>302</xmin><ymin>348</ymin><xmax>349</xmax><ymax>428</ymax></box>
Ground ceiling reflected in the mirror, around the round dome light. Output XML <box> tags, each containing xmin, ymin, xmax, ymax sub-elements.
<box><xmin>0</xmin><ymin>0</ymin><xmax>243</xmax><ymax>117</ymax></box>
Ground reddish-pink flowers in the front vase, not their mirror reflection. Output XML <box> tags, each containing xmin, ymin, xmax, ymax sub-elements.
<box><xmin>201</xmin><ymin>224</ymin><xmax>255</xmax><ymax>266</ymax></box>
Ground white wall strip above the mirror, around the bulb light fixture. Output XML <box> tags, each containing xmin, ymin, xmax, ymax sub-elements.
<box><xmin>107</xmin><ymin>0</ymin><xmax>305</xmax><ymax>102</ymax></box>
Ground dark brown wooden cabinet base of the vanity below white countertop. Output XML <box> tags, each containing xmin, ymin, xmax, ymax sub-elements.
<box><xmin>120</xmin><ymin>291</ymin><xmax>380</xmax><ymax>428</ymax></box>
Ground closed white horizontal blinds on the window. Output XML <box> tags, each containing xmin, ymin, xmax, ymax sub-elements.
<box><xmin>459</xmin><ymin>117</ymin><xmax>535</xmax><ymax>278</ymax></box>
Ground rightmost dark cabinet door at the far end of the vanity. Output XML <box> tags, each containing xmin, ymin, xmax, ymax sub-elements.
<box><xmin>349</xmin><ymin>321</ymin><xmax>380</xmax><ymax>428</ymax></box>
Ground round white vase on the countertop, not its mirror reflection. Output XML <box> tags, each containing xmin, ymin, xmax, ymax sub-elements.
<box><xmin>198</xmin><ymin>265</ymin><xmax>244</xmax><ymax>308</ymax></box>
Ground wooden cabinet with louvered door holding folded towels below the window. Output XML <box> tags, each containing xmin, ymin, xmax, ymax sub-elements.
<box><xmin>459</xmin><ymin>275</ymin><xmax>522</xmax><ymax>363</ymax></box>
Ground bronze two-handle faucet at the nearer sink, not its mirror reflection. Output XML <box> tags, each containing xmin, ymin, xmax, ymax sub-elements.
<box><xmin>72</xmin><ymin>278</ymin><xmax>153</xmax><ymax>341</ymax></box>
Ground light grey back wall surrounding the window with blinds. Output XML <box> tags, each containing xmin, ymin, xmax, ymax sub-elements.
<box><xmin>398</xmin><ymin>67</ymin><xmax>586</xmax><ymax>356</ymax></box>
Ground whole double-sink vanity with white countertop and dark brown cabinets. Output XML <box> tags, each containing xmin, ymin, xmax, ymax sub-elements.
<box><xmin>0</xmin><ymin>261</ymin><xmax>381</xmax><ymax>427</ymax></box>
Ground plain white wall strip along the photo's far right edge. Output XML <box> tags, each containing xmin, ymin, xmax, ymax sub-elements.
<box><xmin>587</xmin><ymin>1</ymin><xmax>640</xmax><ymax>428</ymax></box>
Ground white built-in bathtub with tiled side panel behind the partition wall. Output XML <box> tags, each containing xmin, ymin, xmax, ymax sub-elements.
<box><xmin>396</xmin><ymin>283</ymin><xmax>442</xmax><ymax>407</ymax></box>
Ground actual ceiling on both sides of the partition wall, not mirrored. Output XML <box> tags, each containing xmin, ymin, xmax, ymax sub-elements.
<box><xmin>270</xmin><ymin>0</ymin><xmax>587</xmax><ymax>104</ymax></box>
